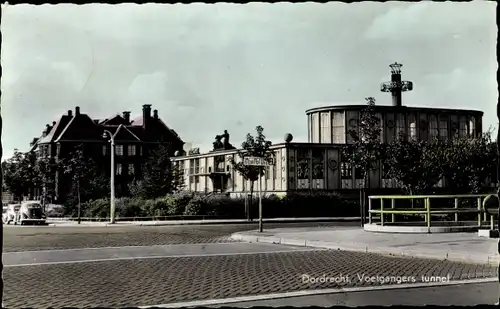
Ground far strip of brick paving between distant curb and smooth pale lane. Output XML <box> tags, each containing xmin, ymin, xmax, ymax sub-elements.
<box><xmin>3</xmin><ymin>222</ymin><xmax>359</xmax><ymax>252</ymax></box>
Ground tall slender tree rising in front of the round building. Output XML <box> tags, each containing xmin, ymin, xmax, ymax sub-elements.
<box><xmin>342</xmin><ymin>97</ymin><xmax>384</xmax><ymax>220</ymax></box>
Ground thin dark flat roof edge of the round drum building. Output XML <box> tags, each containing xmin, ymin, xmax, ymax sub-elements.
<box><xmin>306</xmin><ymin>104</ymin><xmax>484</xmax><ymax>116</ymax></box>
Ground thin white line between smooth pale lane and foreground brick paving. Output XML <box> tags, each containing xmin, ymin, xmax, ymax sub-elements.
<box><xmin>3</xmin><ymin>248</ymin><xmax>328</xmax><ymax>268</ymax></box>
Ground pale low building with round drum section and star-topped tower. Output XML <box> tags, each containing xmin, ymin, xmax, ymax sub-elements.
<box><xmin>173</xmin><ymin>63</ymin><xmax>483</xmax><ymax>195</ymax></box>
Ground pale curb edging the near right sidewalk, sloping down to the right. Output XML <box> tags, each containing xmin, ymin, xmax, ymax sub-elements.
<box><xmin>231</xmin><ymin>233</ymin><xmax>500</xmax><ymax>266</ymax></box>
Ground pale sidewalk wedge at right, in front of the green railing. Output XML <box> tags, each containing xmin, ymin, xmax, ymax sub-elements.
<box><xmin>231</xmin><ymin>227</ymin><xmax>500</xmax><ymax>265</ymax></box>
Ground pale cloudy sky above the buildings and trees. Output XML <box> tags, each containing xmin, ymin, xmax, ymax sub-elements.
<box><xmin>1</xmin><ymin>1</ymin><xmax>498</xmax><ymax>159</ymax></box>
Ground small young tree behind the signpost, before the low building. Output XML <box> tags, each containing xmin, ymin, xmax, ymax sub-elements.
<box><xmin>229</xmin><ymin>126</ymin><xmax>274</xmax><ymax>216</ymax></box>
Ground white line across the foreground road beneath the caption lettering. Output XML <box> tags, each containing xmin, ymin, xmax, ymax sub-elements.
<box><xmin>138</xmin><ymin>278</ymin><xmax>498</xmax><ymax>309</ymax></box>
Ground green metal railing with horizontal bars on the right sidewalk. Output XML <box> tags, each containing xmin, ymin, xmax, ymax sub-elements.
<box><xmin>368</xmin><ymin>194</ymin><xmax>495</xmax><ymax>229</ymax></box>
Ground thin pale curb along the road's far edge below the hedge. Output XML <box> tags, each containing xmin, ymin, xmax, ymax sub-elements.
<box><xmin>48</xmin><ymin>217</ymin><xmax>361</xmax><ymax>227</ymax></box>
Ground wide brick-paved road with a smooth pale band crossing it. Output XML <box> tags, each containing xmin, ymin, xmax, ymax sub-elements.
<box><xmin>3</xmin><ymin>223</ymin><xmax>497</xmax><ymax>308</ymax></box>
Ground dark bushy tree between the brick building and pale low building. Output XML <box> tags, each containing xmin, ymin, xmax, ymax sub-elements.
<box><xmin>129</xmin><ymin>146</ymin><xmax>184</xmax><ymax>199</ymax></box>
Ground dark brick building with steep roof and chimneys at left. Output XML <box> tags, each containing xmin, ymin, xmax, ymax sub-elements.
<box><xmin>30</xmin><ymin>105</ymin><xmax>184</xmax><ymax>202</ymax></box>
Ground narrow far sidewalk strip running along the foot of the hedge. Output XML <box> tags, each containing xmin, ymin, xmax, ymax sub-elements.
<box><xmin>47</xmin><ymin>217</ymin><xmax>361</xmax><ymax>227</ymax></box>
